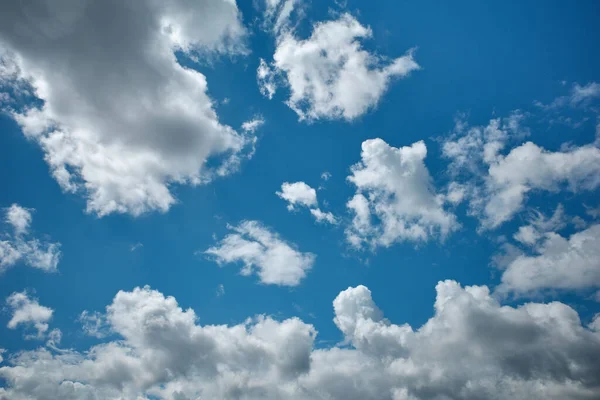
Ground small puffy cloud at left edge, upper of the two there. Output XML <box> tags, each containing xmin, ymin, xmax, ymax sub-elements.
<box><xmin>0</xmin><ymin>204</ymin><xmax>60</xmax><ymax>273</ymax></box>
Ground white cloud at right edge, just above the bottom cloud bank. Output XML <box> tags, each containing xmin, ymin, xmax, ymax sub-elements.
<box><xmin>498</xmin><ymin>224</ymin><xmax>600</xmax><ymax>294</ymax></box>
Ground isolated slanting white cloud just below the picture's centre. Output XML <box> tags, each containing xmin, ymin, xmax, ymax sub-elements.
<box><xmin>205</xmin><ymin>221</ymin><xmax>316</xmax><ymax>286</ymax></box>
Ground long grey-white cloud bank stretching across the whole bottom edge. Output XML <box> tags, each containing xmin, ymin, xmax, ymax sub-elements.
<box><xmin>0</xmin><ymin>281</ymin><xmax>600</xmax><ymax>400</ymax></box>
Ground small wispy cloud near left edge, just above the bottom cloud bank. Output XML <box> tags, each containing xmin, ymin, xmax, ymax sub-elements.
<box><xmin>6</xmin><ymin>292</ymin><xmax>53</xmax><ymax>338</ymax></box>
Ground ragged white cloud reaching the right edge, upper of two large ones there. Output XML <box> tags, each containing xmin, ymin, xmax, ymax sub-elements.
<box><xmin>443</xmin><ymin>113</ymin><xmax>600</xmax><ymax>229</ymax></box>
